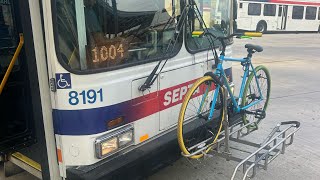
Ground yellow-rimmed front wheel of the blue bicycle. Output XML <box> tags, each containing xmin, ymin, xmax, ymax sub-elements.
<box><xmin>177</xmin><ymin>76</ymin><xmax>225</xmax><ymax>159</ymax></box>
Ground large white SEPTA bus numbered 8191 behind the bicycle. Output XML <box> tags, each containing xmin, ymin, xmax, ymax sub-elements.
<box><xmin>0</xmin><ymin>0</ymin><xmax>233</xmax><ymax>180</ymax></box>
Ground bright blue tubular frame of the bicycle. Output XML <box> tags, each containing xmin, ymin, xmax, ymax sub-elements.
<box><xmin>206</xmin><ymin>55</ymin><xmax>264</xmax><ymax>120</ymax></box>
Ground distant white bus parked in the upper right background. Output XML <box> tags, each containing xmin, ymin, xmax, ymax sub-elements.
<box><xmin>237</xmin><ymin>0</ymin><xmax>320</xmax><ymax>32</ymax></box>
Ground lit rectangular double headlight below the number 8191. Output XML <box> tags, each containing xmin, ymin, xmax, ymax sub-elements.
<box><xmin>95</xmin><ymin>125</ymin><xmax>133</xmax><ymax>158</ymax></box>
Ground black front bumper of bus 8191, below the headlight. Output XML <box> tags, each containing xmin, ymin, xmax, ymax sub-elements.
<box><xmin>67</xmin><ymin>116</ymin><xmax>241</xmax><ymax>180</ymax></box>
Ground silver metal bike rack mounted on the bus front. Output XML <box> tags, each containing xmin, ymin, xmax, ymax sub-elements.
<box><xmin>182</xmin><ymin>87</ymin><xmax>300</xmax><ymax>180</ymax></box>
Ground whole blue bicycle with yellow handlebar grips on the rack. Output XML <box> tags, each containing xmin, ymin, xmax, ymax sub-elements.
<box><xmin>177</xmin><ymin>32</ymin><xmax>271</xmax><ymax>159</ymax></box>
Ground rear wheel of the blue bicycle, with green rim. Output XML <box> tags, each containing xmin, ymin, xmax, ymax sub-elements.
<box><xmin>241</xmin><ymin>65</ymin><xmax>271</xmax><ymax>128</ymax></box>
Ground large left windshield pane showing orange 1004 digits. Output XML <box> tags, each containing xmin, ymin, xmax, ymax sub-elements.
<box><xmin>55</xmin><ymin>0</ymin><xmax>182</xmax><ymax>71</ymax></box>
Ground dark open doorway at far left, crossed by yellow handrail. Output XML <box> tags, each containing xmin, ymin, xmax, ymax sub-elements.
<box><xmin>0</xmin><ymin>0</ymin><xmax>34</xmax><ymax>155</ymax></box>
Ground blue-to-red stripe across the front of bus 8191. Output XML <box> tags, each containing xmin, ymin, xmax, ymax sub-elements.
<box><xmin>53</xmin><ymin>68</ymin><xmax>232</xmax><ymax>135</ymax></box>
